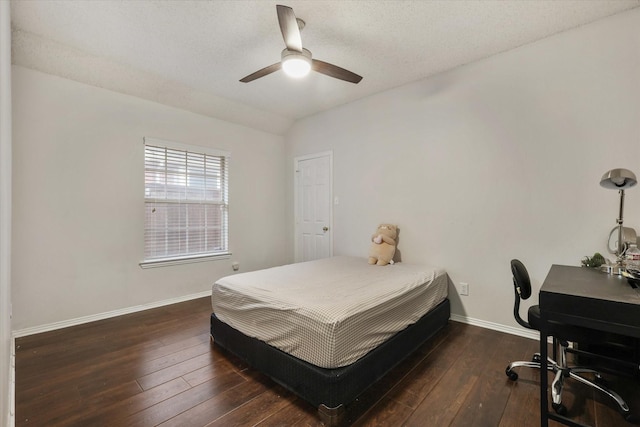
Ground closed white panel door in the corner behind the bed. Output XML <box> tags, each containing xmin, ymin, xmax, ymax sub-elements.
<box><xmin>294</xmin><ymin>152</ymin><xmax>333</xmax><ymax>262</ymax></box>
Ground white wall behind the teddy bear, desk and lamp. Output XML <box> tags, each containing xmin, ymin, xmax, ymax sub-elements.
<box><xmin>287</xmin><ymin>9</ymin><xmax>640</xmax><ymax>327</ymax></box>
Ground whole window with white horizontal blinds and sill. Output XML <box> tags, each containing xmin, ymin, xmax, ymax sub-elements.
<box><xmin>141</xmin><ymin>138</ymin><xmax>229</xmax><ymax>267</ymax></box>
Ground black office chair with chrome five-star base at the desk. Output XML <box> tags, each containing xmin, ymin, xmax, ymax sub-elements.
<box><xmin>505</xmin><ymin>259</ymin><xmax>631</xmax><ymax>419</ymax></box>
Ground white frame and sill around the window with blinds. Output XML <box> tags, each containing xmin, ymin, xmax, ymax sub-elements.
<box><xmin>139</xmin><ymin>137</ymin><xmax>231</xmax><ymax>268</ymax></box>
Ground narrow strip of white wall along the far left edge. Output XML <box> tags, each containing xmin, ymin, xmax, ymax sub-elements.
<box><xmin>0</xmin><ymin>1</ymin><xmax>14</xmax><ymax>426</ymax></box>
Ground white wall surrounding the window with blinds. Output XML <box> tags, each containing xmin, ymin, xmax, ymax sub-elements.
<box><xmin>13</xmin><ymin>66</ymin><xmax>291</xmax><ymax>330</ymax></box>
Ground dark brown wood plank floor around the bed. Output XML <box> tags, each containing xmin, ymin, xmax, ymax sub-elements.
<box><xmin>16</xmin><ymin>298</ymin><xmax>640</xmax><ymax>427</ymax></box>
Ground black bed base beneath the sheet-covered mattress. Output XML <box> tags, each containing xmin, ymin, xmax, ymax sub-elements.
<box><xmin>211</xmin><ymin>299</ymin><xmax>450</xmax><ymax>425</ymax></box>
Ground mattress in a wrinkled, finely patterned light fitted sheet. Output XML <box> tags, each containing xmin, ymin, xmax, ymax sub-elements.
<box><xmin>211</xmin><ymin>256</ymin><xmax>448</xmax><ymax>368</ymax></box>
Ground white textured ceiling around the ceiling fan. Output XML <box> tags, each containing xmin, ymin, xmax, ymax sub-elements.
<box><xmin>11</xmin><ymin>0</ymin><xmax>640</xmax><ymax>134</ymax></box>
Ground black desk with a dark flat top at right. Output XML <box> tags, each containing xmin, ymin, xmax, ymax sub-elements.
<box><xmin>539</xmin><ymin>265</ymin><xmax>640</xmax><ymax>427</ymax></box>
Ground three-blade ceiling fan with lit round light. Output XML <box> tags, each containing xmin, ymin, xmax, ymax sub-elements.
<box><xmin>240</xmin><ymin>5</ymin><xmax>362</xmax><ymax>83</ymax></box>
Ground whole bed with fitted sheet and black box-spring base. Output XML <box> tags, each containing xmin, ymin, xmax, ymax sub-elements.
<box><xmin>211</xmin><ymin>256</ymin><xmax>450</xmax><ymax>425</ymax></box>
